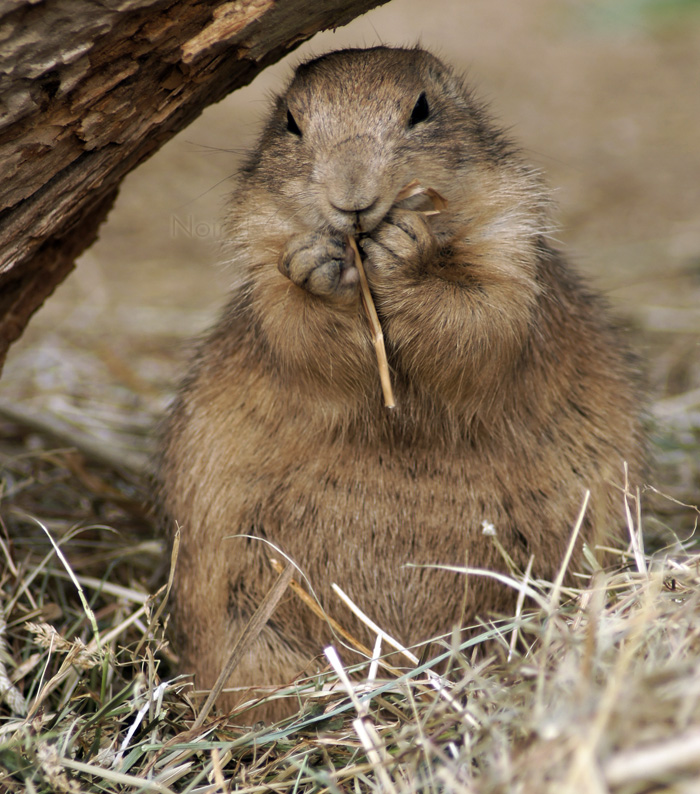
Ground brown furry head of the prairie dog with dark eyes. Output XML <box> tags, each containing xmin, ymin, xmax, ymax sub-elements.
<box><xmin>246</xmin><ymin>47</ymin><xmax>540</xmax><ymax>244</ymax></box>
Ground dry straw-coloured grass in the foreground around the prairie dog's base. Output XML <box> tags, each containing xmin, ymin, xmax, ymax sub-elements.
<box><xmin>0</xmin><ymin>396</ymin><xmax>700</xmax><ymax>794</ymax></box>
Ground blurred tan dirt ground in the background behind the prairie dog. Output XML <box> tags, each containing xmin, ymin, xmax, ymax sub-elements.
<box><xmin>0</xmin><ymin>0</ymin><xmax>700</xmax><ymax>504</ymax></box>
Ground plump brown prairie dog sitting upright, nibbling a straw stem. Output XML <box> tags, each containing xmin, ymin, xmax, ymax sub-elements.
<box><xmin>160</xmin><ymin>47</ymin><xmax>643</xmax><ymax>716</ymax></box>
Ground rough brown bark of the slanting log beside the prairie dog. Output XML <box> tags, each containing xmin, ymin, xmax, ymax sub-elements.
<box><xmin>0</xmin><ymin>0</ymin><xmax>386</xmax><ymax>369</ymax></box>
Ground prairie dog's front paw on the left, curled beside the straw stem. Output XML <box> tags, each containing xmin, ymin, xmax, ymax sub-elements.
<box><xmin>278</xmin><ymin>232</ymin><xmax>359</xmax><ymax>303</ymax></box>
